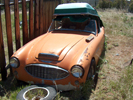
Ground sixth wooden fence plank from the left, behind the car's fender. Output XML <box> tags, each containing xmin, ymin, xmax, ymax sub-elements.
<box><xmin>34</xmin><ymin>0</ymin><xmax>39</xmax><ymax>37</ymax></box>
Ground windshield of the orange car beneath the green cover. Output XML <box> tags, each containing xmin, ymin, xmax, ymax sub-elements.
<box><xmin>48</xmin><ymin>17</ymin><xmax>96</xmax><ymax>34</ymax></box>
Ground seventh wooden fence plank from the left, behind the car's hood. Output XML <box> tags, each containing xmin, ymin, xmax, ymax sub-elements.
<box><xmin>39</xmin><ymin>0</ymin><xmax>43</xmax><ymax>35</ymax></box>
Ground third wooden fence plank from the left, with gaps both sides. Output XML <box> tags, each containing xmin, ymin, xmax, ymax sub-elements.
<box><xmin>14</xmin><ymin>0</ymin><xmax>21</xmax><ymax>50</ymax></box>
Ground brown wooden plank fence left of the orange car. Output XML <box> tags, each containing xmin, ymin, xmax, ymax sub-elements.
<box><xmin>0</xmin><ymin>0</ymin><xmax>61</xmax><ymax>80</ymax></box>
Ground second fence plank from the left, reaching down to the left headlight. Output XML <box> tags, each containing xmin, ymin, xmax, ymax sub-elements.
<box><xmin>4</xmin><ymin>0</ymin><xmax>13</xmax><ymax>74</ymax></box>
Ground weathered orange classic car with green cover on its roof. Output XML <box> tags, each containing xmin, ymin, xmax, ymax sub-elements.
<box><xmin>10</xmin><ymin>3</ymin><xmax>105</xmax><ymax>91</ymax></box>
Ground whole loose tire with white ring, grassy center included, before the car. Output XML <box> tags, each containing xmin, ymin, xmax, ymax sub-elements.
<box><xmin>16</xmin><ymin>85</ymin><xmax>56</xmax><ymax>100</ymax></box>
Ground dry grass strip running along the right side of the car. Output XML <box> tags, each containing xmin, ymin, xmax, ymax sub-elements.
<box><xmin>90</xmin><ymin>9</ymin><xmax>133</xmax><ymax>100</ymax></box>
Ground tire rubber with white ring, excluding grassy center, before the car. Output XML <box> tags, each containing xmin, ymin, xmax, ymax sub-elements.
<box><xmin>16</xmin><ymin>85</ymin><xmax>56</xmax><ymax>100</ymax></box>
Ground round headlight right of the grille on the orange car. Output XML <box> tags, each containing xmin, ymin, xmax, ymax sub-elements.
<box><xmin>71</xmin><ymin>65</ymin><xmax>83</xmax><ymax>78</ymax></box>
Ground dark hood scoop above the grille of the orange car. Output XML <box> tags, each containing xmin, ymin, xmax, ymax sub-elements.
<box><xmin>37</xmin><ymin>53</ymin><xmax>59</xmax><ymax>60</ymax></box>
